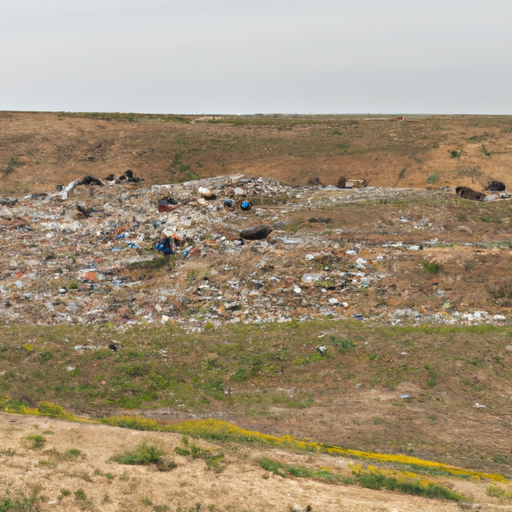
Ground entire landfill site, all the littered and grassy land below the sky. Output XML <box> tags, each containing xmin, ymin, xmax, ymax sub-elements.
<box><xmin>0</xmin><ymin>113</ymin><xmax>512</xmax><ymax>512</ymax></box>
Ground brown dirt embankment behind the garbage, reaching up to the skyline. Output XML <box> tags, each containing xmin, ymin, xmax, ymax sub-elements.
<box><xmin>0</xmin><ymin>112</ymin><xmax>512</xmax><ymax>194</ymax></box>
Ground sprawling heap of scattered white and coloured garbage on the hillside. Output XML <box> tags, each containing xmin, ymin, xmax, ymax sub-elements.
<box><xmin>0</xmin><ymin>173</ymin><xmax>507</xmax><ymax>331</ymax></box>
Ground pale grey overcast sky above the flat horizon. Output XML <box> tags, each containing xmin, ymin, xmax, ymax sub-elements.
<box><xmin>0</xmin><ymin>0</ymin><xmax>512</xmax><ymax>115</ymax></box>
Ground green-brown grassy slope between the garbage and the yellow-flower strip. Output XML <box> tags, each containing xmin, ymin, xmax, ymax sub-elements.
<box><xmin>0</xmin><ymin>321</ymin><xmax>512</xmax><ymax>473</ymax></box>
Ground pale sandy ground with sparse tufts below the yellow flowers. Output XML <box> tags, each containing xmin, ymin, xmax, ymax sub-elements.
<box><xmin>0</xmin><ymin>413</ymin><xmax>496</xmax><ymax>512</ymax></box>
